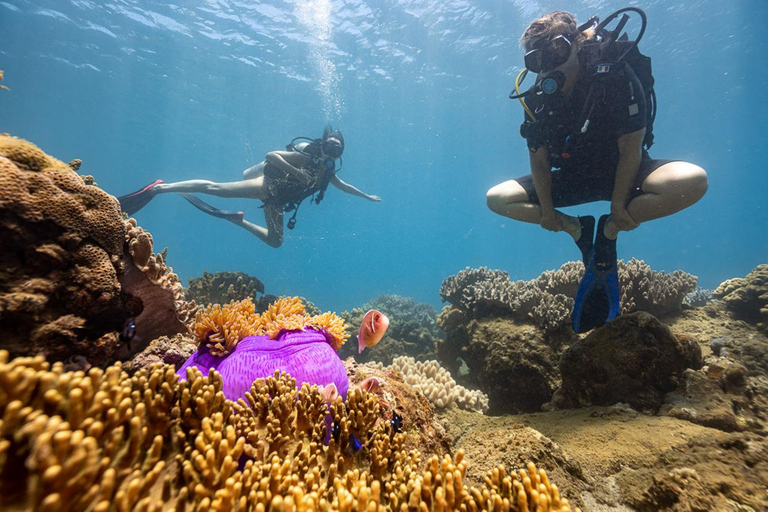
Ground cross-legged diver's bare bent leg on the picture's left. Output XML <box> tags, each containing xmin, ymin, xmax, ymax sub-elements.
<box><xmin>486</xmin><ymin>180</ymin><xmax>581</xmax><ymax>240</ymax></box>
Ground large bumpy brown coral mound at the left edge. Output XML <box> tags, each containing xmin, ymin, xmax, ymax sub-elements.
<box><xmin>0</xmin><ymin>135</ymin><xmax>195</xmax><ymax>364</ymax></box>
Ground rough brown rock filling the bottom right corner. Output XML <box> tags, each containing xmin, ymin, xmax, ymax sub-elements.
<box><xmin>617</xmin><ymin>433</ymin><xmax>768</xmax><ymax>512</ymax></box>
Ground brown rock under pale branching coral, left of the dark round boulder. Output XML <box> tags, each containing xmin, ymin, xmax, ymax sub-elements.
<box><xmin>437</xmin><ymin>310</ymin><xmax>577</xmax><ymax>414</ymax></box>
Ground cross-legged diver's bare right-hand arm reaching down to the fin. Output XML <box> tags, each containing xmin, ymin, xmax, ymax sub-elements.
<box><xmin>611</xmin><ymin>128</ymin><xmax>645</xmax><ymax>230</ymax></box>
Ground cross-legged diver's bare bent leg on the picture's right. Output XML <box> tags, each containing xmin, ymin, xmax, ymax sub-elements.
<box><xmin>605</xmin><ymin>162</ymin><xmax>709</xmax><ymax>238</ymax></box>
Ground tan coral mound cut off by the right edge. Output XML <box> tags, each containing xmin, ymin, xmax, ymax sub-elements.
<box><xmin>714</xmin><ymin>263</ymin><xmax>768</xmax><ymax>335</ymax></box>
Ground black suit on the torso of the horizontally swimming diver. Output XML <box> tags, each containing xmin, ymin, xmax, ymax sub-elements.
<box><xmin>263</xmin><ymin>149</ymin><xmax>336</xmax><ymax>207</ymax></box>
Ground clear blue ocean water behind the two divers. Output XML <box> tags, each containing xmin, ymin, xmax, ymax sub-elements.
<box><xmin>0</xmin><ymin>0</ymin><xmax>768</xmax><ymax>310</ymax></box>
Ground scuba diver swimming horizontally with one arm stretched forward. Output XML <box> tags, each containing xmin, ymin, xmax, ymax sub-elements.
<box><xmin>118</xmin><ymin>125</ymin><xmax>381</xmax><ymax>248</ymax></box>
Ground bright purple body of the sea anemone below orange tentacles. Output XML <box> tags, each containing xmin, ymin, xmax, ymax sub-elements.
<box><xmin>176</xmin><ymin>328</ymin><xmax>349</xmax><ymax>400</ymax></box>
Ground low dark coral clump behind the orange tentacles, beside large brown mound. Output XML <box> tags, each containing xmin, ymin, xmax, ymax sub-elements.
<box><xmin>185</xmin><ymin>270</ymin><xmax>264</xmax><ymax>304</ymax></box>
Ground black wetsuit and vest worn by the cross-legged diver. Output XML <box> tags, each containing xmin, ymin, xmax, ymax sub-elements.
<box><xmin>516</xmin><ymin>56</ymin><xmax>671</xmax><ymax>208</ymax></box>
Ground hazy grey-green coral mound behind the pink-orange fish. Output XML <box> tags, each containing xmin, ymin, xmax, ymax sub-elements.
<box><xmin>339</xmin><ymin>295</ymin><xmax>440</xmax><ymax>365</ymax></box>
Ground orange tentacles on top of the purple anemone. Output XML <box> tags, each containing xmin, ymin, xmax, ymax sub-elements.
<box><xmin>193</xmin><ymin>297</ymin><xmax>349</xmax><ymax>356</ymax></box>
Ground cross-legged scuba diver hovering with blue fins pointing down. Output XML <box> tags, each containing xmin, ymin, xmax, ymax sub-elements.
<box><xmin>487</xmin><ymin>7</ymin><xmax>708</xmax><ymax>333</ymax></box>
